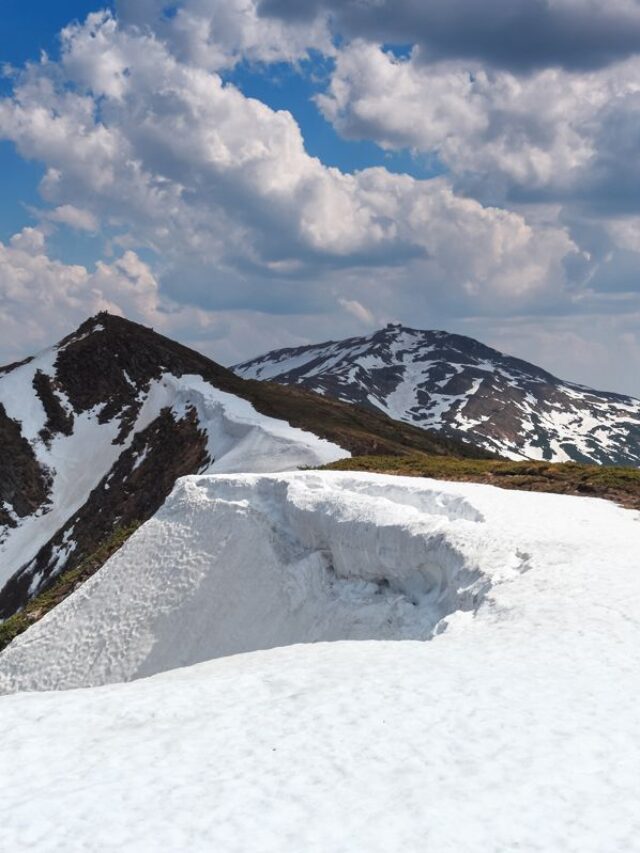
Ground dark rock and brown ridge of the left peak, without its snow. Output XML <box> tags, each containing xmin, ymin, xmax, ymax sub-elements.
<box><xmin>0</xmin><ymin>313</ymin><xmax>486</xmax><ymax>619</ymax></box>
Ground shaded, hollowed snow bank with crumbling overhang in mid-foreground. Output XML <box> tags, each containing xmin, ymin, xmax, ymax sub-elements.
<box><xmin>0</xmin><ymin>472</ymin><xmax>490</xmax><ymax>692</ymax></box>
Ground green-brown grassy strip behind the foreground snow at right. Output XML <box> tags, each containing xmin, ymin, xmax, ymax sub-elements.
<box><xmin>326</xmin><ymin>453</ymin><xmax>640</xmax><ymax>510</ymax></box>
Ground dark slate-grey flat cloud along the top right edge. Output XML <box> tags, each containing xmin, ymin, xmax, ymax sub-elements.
<box><xmin>259</xmin><ymin>0</ymin><xmax>640</xmax><ymax>71</ymax></box>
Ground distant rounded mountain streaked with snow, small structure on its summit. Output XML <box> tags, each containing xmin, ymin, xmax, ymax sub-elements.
<box><xmin>233</xmin><ymin>324</ymin><xmax>640</xmax><ymax>466</ymax></box>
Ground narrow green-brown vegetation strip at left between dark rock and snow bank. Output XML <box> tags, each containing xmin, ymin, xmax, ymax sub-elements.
<box><xmin>0</xmin><ymin>522</ymin><xmax>140</xmax><ymax>652</ymax></box>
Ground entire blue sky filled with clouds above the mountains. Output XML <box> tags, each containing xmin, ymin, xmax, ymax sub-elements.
<box><xmin>0</xmin><ymin>0</ymin><xmax>640</xmax><ymax>396</ymax></box>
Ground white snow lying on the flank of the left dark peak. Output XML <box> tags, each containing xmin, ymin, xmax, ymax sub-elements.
<box><xmin>0</xmin><ymin>356</ymin><xmax>350</xmax><ymax>587</ymax></box>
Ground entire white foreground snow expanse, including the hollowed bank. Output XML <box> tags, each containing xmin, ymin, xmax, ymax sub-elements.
<box><xmin>0</xmin><ymin>471</ymin><xmax>640</xmax><ymax>853</ymax></box>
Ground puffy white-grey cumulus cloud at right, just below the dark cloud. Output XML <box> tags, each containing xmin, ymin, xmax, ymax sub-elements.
<box><xmin>317</xmin><ymin>42</ymin><xmax>640</xmax><ymax>209</ymax></box>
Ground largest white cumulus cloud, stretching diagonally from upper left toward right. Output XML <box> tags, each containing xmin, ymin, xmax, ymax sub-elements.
<box><xmin>0</xmin><ymin>13</ymin><xmax>576</xmax><ymax>320</ymax></box>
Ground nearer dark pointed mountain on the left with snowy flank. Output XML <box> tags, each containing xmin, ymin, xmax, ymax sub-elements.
<box><xmin>0</xmin><ymin>313</ymin><xmax>484</xmax><ymax>619</ymax></box>
